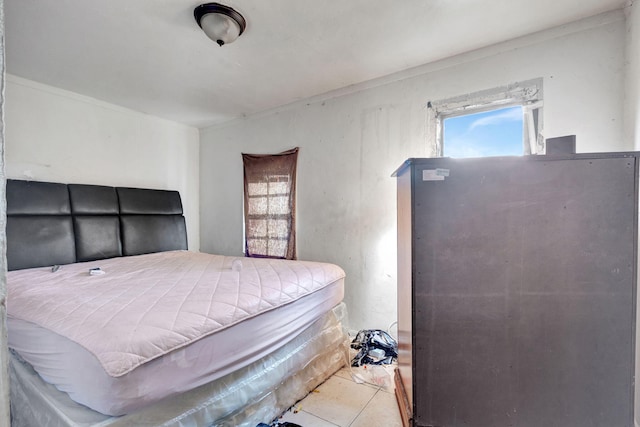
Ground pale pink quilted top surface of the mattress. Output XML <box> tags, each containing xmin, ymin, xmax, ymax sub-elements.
<box><xmin>7</xmin><ymin>251</ymin><xmax>344</xmax><ymax>377</ymax></box>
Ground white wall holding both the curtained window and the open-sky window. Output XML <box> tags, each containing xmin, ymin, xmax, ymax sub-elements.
<box><xmin>200</xmin><ymin>12</ymin><xmax>633</xmax><ymax>329</ymax></box>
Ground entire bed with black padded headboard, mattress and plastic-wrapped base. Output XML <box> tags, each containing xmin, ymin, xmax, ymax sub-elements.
<box><xmin>6</xmin><ymin>180</ymin><xmax>348</xmax><ymax>427</ymax></box>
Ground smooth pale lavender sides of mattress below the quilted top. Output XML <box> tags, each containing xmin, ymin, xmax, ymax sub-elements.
<box><xmin>8</xmin><ymin>252</ymin><xmax>344</xmax><ymax>415</ymax></box>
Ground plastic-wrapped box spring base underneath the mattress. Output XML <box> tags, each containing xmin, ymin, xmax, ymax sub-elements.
<box><xmin>9</xmin><ymin>303</ymin><xmax>349</xmax><ymax>427</ymax></box>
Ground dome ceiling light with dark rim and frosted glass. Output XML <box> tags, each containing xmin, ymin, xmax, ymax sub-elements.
<box><xmin>193</xmin><ymin>3</ymin><xmax>247</xmax><ymax>46</ymax></box>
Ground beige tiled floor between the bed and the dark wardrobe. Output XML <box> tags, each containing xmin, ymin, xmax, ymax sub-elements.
<box><xmin>272</xmin><ymin>366</ymin><xmax>402</xmax><ymax>427</ymax></box>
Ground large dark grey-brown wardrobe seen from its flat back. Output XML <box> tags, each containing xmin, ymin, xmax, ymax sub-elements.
<box><xmin>395</xmin><ymin>153</ymin><xmax>639</xmax><ymax>427</ymax></box>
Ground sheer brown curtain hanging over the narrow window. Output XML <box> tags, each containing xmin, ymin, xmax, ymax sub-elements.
<box><xmin>242</xmin><ymin>147</ymin><xmax>298</xmax><ymax>259</ymax></box>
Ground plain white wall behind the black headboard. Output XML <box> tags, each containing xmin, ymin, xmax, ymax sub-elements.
<box><xmin>5</xmin><ymin>76</ymin><xmax>200</xmax><ymax>251</ymax></box>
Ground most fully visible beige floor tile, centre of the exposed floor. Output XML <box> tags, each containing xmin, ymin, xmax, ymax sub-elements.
<box><xmin>296</xmin><ymin>375</ymin><xmax>377</xmax><ymax>426</ymax></box>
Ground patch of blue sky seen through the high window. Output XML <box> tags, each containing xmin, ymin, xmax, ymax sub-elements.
<box><xmin>442</xmin><ymin>106</ymin><xmax>523</xmax><ymax>157</ymax></box>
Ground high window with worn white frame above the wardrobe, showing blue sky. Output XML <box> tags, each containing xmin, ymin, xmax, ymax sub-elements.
<box><xmin>428</xmin><ymin>79</ymin><xmax>545</xmax><ymax>157</ymax></box>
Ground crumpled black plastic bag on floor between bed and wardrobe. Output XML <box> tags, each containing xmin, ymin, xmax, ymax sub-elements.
<box><xmin>351</xmin><ymin>329</ymin><xmax>398</xmax><ymax>366</ymax></box>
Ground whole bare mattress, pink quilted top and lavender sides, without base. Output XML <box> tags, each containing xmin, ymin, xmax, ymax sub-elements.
<box><xmin>7</xmin><ymin>251</ymin><xmax>344</xmax><ymax>415</ymax></box>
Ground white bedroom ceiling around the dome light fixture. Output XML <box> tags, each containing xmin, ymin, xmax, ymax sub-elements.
<box><xmin>4</xmin><ymin>0</ymin><xmax>628</xmax><ymax>127</ymax></box>
